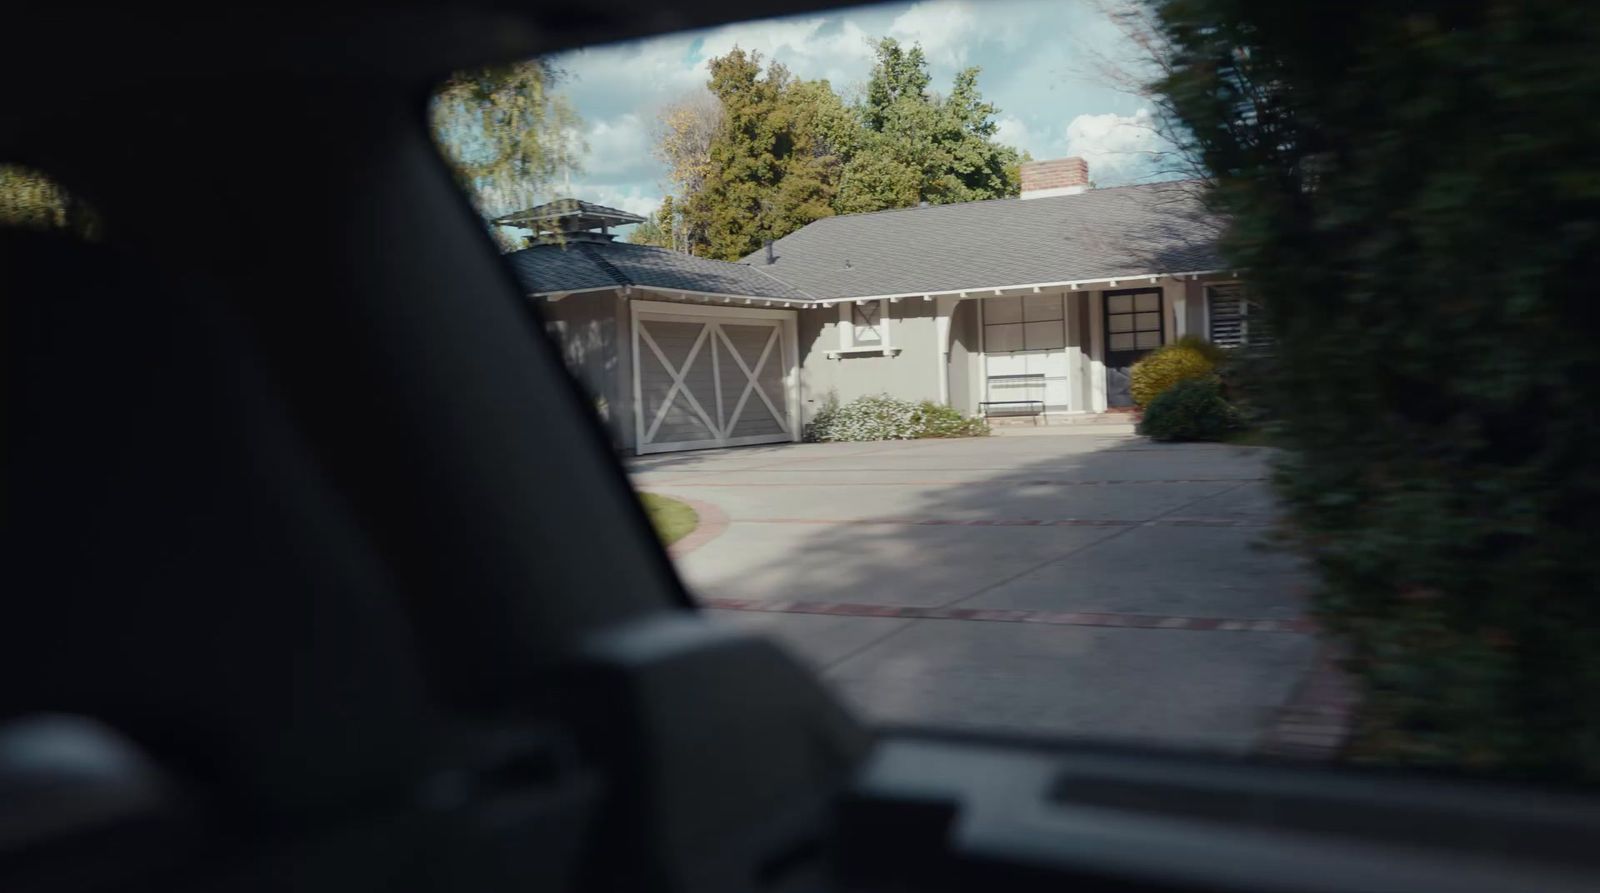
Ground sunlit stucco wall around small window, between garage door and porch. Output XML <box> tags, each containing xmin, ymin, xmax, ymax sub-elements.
<box><xmin>798</xmin><ymin>298</ymin><xmax>942</xmax><ymax>421</ymax></box>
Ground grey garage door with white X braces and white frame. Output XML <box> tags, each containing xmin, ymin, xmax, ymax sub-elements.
<box><xmin>632</xmin><ymin>301</ymin><xmax>800</xmax><ymax>453</ymax></box>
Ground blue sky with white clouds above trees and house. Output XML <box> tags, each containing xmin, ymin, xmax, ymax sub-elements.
<box><xmin>552</xmin><ymin>0</ymin><xmax>1170</xmax><ymax>222</ymax></box>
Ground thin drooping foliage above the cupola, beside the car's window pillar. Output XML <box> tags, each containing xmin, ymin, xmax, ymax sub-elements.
<box><xmin>432</xmin><ymin>59</ymin><xmax>584</xmax><ymax>248</ymax></box>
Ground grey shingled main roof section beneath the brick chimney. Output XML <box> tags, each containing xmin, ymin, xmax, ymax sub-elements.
<box><xmin>746</xmin><ymin>181</ymin><xmax>1224</xmax><ymax>299</ymax></box>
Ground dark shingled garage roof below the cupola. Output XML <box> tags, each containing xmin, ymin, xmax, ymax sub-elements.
<box><xmin>506</xmin><ymin>240</ymin><xmax>811</xmax><ymax>301</ymax></box>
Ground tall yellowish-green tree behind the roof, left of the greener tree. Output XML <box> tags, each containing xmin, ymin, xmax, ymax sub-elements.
<box><xmin>683</xmin><ymin>48</ymin><xmax>840</xmax><ymax>259</ymax></box>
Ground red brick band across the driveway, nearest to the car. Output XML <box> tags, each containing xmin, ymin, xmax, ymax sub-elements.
<box><xmin>699</xmin><ymin>599</ymin><xmax>1315</xmax><ymax>634</ymax></box>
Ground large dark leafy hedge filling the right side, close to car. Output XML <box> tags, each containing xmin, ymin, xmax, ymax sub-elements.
<box><xmin>1152</xmin><ymin>0</ymin><xmax>1600</xmax><ymax>781</ymax></box>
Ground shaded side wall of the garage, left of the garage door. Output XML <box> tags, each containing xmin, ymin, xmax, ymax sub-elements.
<box><xmin>539</xmin><ymin>291</ymin><xmax>634</xmax><ymax>448</ymax></box>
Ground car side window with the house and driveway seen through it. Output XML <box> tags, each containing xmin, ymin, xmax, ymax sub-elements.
<box><xmin>430</xmin><ymin>0</ymin><xmax>1600</xmax><ymax>779</ymax></box>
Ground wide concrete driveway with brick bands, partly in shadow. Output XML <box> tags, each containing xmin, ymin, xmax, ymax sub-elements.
<box><xmin>630</xmin><ymin>426</ymin><xmax>1317</xmax><ymax>752</ymax></box>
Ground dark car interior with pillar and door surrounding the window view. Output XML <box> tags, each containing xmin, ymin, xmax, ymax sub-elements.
<box><xmin>9</xmin><ymin>0</ymin><xmax>1600</xmax><ymax>893</ymax></box>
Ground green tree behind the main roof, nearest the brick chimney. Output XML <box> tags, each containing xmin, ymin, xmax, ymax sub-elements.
<box><xmin>835</xmin><ymin>38</ymin><xmax>1021</xmax><ymax>213</ymax></box>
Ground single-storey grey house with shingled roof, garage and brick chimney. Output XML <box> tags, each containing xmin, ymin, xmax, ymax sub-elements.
<box><xmin>508</xmin><ymin>158</ymin><xmax>1248</xmax><ymax>453</ymax></box>
